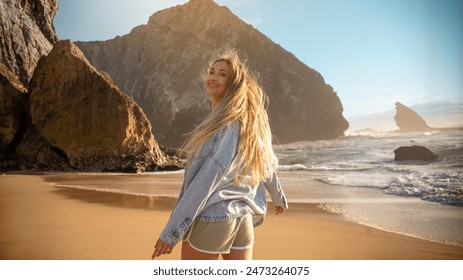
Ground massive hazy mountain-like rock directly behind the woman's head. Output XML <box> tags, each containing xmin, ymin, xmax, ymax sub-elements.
<box><xmin>77</xmin><ymin>0</ymin><xmax>348</xmax><ymax>147</ymax></box>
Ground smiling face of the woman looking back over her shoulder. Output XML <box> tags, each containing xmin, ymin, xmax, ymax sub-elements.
<box><xmin>205</xmin><ymin>61</ymin><xmax>231</xmax><ymax>103</ymax></box>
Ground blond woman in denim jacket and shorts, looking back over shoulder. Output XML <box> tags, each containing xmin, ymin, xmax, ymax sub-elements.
<box><xmin>152</xmin><ymin>51</ymin><xmax>288</xmax><ymax>260</ymax></box>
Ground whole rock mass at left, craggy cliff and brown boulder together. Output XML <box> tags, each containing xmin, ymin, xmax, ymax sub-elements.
<box><xmin>0</xmin><ymin>0</ymin><xmax>178</xmax><ymax>172</ymax></box>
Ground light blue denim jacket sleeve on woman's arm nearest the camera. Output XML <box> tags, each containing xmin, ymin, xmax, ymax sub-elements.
<box><xmin>160</xmin><ymin>123</ymin><xmax>239</xmax><ymax>246</ymax></box>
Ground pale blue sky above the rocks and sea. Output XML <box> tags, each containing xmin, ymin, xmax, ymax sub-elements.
<box><xmin>55</xmin><ymin>0</ymin><xmax>463</xmax><ymax>126</ymax></box>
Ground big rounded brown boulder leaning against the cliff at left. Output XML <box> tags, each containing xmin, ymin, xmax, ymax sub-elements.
<box><xmin>29</xmin><ymin>41</ymin><xmax>166</xmax><ymax>171</ymax></box>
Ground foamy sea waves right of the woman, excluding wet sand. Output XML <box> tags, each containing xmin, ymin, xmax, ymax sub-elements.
<box><xmin>275</xmin><ymin>131</ymin><xmax>463</xmax><ymax>207</ymax></box>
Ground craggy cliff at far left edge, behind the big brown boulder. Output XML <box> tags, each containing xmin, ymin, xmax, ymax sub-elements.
<box><xmin>0</xmin><ymin>0</ymin><xmax>58</xmax><ymax>162</ymax></box>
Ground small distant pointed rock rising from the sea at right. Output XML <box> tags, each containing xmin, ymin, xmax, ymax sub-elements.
<box><xmin>394</xmin><ymin>102</ymin><xmax>433</xmax><ymax>132</ymax></box>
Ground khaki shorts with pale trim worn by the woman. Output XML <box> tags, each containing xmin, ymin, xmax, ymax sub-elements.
<box><xmin>184</xmin><ymin>214</ymin><xmax>254</xmax><ymax>254</ymax></box>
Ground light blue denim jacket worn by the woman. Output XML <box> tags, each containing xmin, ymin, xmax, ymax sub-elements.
<box><xmin>160</xmin><ymin>122</ymin><xmax>288</xmax><ymax>246</ymax></box>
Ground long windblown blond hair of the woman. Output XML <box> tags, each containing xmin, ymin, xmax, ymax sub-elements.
<box><xmin>180</xmin><ymin>50</ymin><xmax>278</xmax><ymax>186</ymax></box>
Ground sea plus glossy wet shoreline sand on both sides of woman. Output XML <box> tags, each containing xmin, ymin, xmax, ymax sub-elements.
<box><xmin>48</xmin><ymin>131</ymin><xmax>463</xmax><ymax>246</ymax></box>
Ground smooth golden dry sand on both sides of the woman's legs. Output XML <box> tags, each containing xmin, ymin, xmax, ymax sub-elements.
<box><xmin>0</xmin><ymin>174</ymin><xmax>463</xmax><ymax>260</ymax></box>
